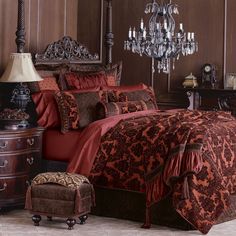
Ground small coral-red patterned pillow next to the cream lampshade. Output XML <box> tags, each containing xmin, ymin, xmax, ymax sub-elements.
<box><xmin>28</xmin><ymin>76</ymin><xmax>60</xmax><ymax>93</ymax></box>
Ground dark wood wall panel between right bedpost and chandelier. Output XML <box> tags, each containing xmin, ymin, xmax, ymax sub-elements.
<box><xmin>113</xmin><ymin>0</ymin><xmax>151</xmax><ymax>84</ymax></box>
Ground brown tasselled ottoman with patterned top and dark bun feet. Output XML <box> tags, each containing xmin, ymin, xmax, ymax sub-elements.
<box><xmin>25</xmin><ymin>172</ymin><xmax>95</xmax><ymax>229</ymax></box>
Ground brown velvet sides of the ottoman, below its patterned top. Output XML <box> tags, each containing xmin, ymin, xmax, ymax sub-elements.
<box><xmin>25</xmin><ymin>183</ymin><xmax>95</xmax><ymax>217</ymax></box>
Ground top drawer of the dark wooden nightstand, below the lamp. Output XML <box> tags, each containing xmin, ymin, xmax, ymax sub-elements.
<box><xmin>0</xmin><ymin>136</ymin><xmax>40</xmax><ymax>152</ymax></box>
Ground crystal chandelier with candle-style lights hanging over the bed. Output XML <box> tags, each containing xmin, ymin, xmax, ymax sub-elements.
<box><xmin>124</xmin><ymin>0</ymin><xmax>198</xmax><ymax>73</ymax></box>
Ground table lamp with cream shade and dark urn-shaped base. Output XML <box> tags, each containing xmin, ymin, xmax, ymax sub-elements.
<box><xmin>0</xmin><ymin>53</ymin><xmax>42</xmax><ymax>128</ymax></box>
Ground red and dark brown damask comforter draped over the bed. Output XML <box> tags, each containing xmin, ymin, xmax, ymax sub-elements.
<box><xmin>87</xmin><ymin>111</ymin><xmax>236</xmax><ymax>233</ymax></box>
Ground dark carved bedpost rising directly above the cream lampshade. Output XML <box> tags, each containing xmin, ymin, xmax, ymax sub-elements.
<box><xmin>16</xmin><ymin>0</ymin><xmax>25</xmax><ymax>53</ymax></box>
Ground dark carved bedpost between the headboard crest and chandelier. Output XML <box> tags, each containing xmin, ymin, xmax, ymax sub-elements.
<box><xmin>105</xmin><ymin>0</ymin><xmax>114</xmax><ymax>65</ymax></box>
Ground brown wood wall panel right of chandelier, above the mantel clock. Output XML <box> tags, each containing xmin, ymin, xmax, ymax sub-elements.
<box><xmin>171</xmin><ymin>0</ymin><xmax>224</xmax><ymax>90</ymax></box>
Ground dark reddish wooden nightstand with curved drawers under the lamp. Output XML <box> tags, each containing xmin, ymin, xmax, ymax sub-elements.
<box><xmin>0</xmin><ymin>127</ymin><xmax>44</xmax><ymax>209</ymax></box>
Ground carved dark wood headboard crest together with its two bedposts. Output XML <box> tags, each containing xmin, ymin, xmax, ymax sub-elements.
<box><xmin>16</xmin><ymin>0</ymin><xmax>114</xmax><ymax>65</ymax></box>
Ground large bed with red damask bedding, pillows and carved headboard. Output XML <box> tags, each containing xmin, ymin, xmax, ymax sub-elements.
<box><xmin>20</xmin><ymin>1</ymin><xmax>236</xmax><ymax>233</ymax></box>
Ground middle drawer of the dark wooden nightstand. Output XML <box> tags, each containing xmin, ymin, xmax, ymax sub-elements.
<box><xmin>0</xmin><ymin>152</ymin><xmax>40</xmax><ymax>175</ymax></box>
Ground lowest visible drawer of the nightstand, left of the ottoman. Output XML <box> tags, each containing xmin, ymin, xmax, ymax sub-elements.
<box><xmin>0</xmin><ymin>175</ymin><xmax>29</xmax><ymax>201</ymax></box>
